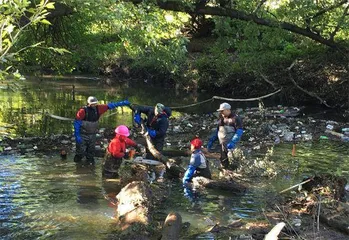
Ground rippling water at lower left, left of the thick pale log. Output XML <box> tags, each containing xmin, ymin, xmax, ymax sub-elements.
<box><xmin>0</xmin><ymin>156</ymin><xmax>114</xmax><ymax>239</ymax></box>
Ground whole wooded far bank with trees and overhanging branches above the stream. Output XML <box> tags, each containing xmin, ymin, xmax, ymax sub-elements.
<box><xmin>0</xmin><ymin>0</ymin><xmax>349</xmax><ymax>109</ymax></box>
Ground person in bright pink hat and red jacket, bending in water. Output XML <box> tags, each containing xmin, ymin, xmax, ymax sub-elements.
<box><xmin>103</xmin><ymin>125</ymin><xmax>137</xmax><ymax>178</ymax></box>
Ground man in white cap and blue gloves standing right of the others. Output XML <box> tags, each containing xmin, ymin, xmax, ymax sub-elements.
<box><xmin>207</xmin><ymin>103</ymin><xmax>244</xmax><ymax>170</ymax></box>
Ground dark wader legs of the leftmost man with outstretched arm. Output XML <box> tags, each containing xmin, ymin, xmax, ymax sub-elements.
<box><xmin>74</xmin><ymin>134</ymin><xmax>96</xmax><ymax>164</ymax></box>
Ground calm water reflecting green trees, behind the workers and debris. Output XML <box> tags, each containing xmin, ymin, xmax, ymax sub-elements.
<box><xmin>0</xmin><ymin>78</ymin><xmax>212</xmax><ymax>136</ymax></box>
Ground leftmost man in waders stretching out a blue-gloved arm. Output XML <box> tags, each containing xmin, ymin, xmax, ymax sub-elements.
<box><xmin>73</xmin><ymin>96</ymin><xmax>130</xmax><ymax>165</ymax></box>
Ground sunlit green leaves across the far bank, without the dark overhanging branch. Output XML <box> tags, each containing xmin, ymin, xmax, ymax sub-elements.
<box><xmin>5</xmin><ymin>0</ymin><xmax>349</xmax><ymax>86</ymax></box>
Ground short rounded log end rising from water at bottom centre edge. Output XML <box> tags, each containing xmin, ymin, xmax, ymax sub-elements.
<box><xmin>161</xmin><ymin>212</ymin><xmax>182</xmax><ymax>240</ymax></box>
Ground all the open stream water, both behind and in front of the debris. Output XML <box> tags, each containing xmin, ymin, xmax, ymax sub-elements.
<box><xmin>0</xmin><ymin>78</ymin><xmax>349</xmax><ymax>239</ymax></box>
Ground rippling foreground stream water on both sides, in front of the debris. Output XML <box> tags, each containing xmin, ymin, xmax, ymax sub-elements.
<box><xmin>0</xmin><ymin>142</ymin><xmax>349</xmax><ymax>239</ymax></box>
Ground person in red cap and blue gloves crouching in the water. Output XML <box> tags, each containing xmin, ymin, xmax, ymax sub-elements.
<box><xmin>183</xmin><ymin>137</ymin><xmax>211</xmax><ymax>187</ymax></box>
